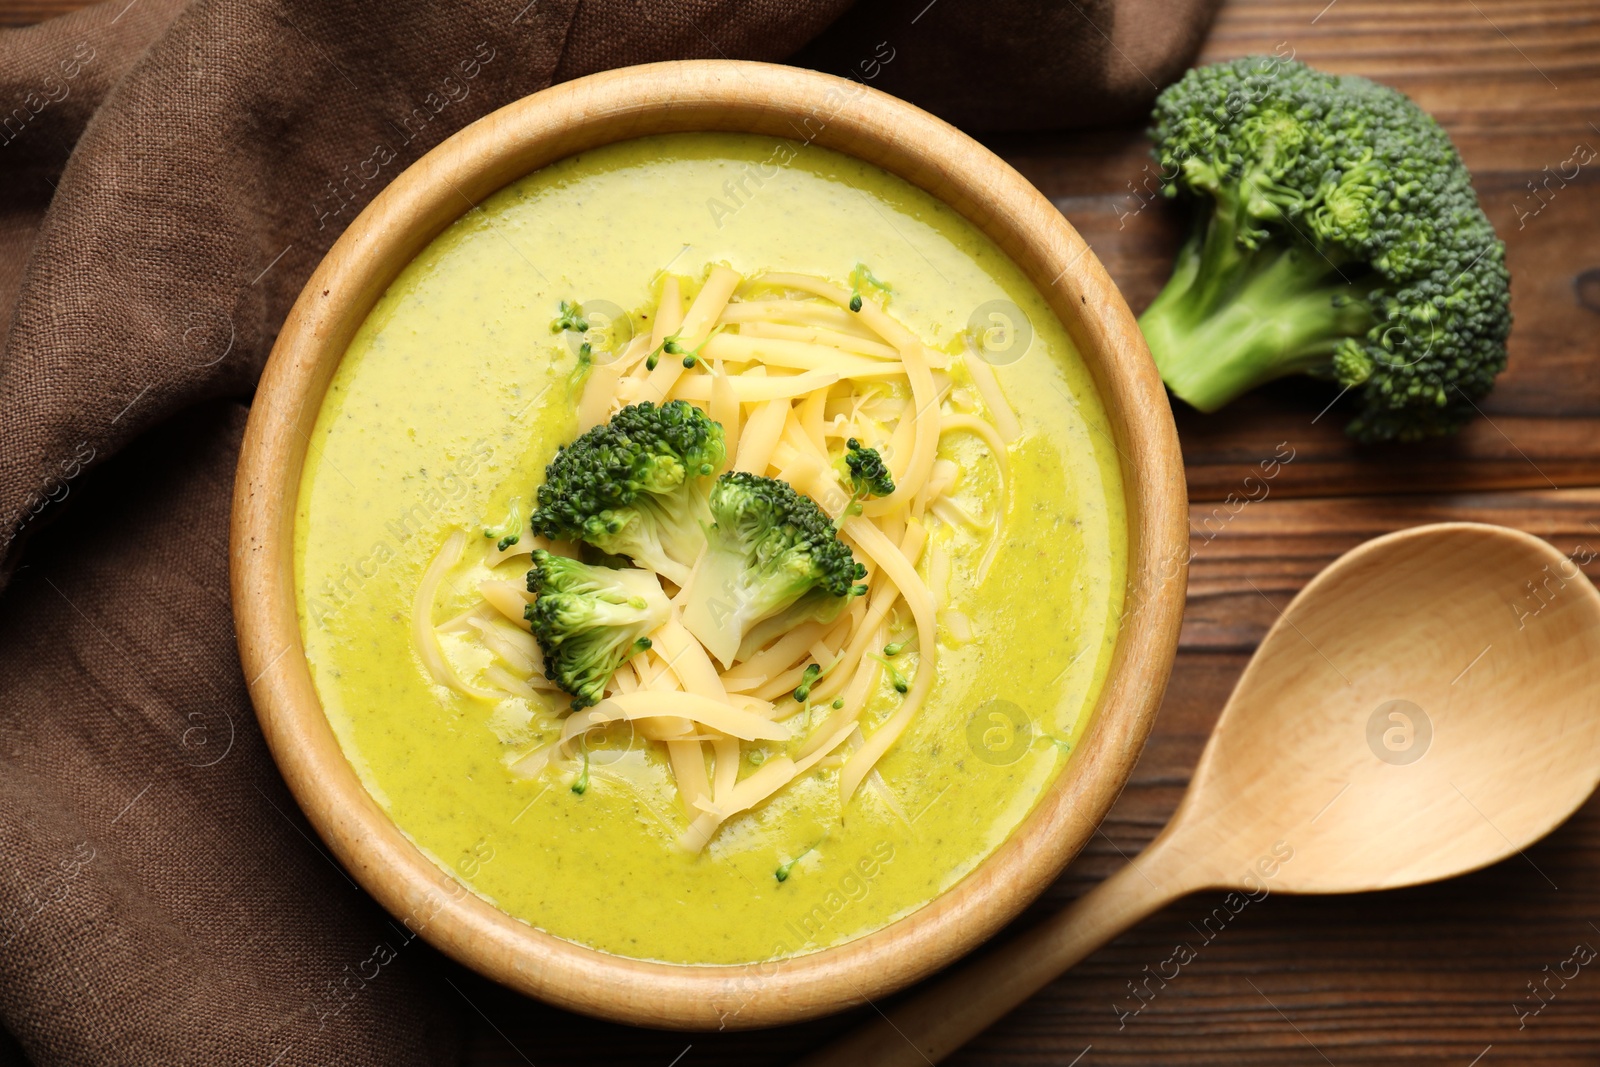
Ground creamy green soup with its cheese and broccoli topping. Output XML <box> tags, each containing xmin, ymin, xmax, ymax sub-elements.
<box><xmin>296</xmin><ymin>134</ymin><xmax>1126</xmax><ymax>963</ymax></box>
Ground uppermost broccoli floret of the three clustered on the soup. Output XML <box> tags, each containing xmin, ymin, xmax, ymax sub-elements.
<box><xmin>533</xmin><ymin>400</ymin><xmax>726</xmax><ymax>585</ymax></box>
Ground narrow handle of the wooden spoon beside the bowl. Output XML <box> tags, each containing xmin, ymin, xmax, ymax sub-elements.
<box><xmin>795</xmin><ymin>840</ymin><xmax>1192</xmax><ymax>1067</ymax></box>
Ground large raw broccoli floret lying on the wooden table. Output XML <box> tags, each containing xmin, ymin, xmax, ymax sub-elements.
<box><xmin>1139</xmin><ymin>56</ymin><xmax>1510</xmax><ymax>440</ymax></box>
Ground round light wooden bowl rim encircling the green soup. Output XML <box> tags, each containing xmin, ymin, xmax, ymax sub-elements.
<box><xmin>230</xmin><ymin>61</ymin><xmax>1189</xmax><ymax>1029</ymax></box>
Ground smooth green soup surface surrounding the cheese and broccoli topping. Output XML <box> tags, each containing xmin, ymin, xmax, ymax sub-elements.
<box><xmin>296</xmin><ymin>134</ymin><xmax>1126</xmax><ymax>963</ymax></box>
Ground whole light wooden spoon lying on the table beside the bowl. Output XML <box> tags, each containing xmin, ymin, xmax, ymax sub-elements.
<box><xmin>802</xmin><ymin>523</ymin><xmax>1600</xmax><ymax>1067</ymax></box>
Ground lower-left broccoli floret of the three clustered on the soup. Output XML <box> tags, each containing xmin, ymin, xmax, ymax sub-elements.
<box><xmin>526</xmin><ymin>549</ymin><xmax>672</xmax><ymax>710</ymax></box>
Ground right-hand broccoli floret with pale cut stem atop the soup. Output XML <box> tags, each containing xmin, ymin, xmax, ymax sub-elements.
<box><xmin>683</xmin><ymin>470</ymin><xmax>866</xmax><ymax>667</ymax></box>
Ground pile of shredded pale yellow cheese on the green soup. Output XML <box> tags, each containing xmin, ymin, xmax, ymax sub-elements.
<box><xmin>438</xmin><ymin>266</ymin><xmax>1021</xmax><ymax>853</ymax></box>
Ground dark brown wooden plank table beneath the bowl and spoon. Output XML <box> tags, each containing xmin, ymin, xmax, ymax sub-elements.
<box><xmin>15</xmin><ymin>0</ymin><xmax>1600</xmax><ymax>1067</ymax></box>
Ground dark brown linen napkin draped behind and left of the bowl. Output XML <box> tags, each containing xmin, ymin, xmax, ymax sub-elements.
<box><xmin>0</xmin><ymin>0</ymin><xmax>1210</xmax><ymax>1067</ymax></box>
